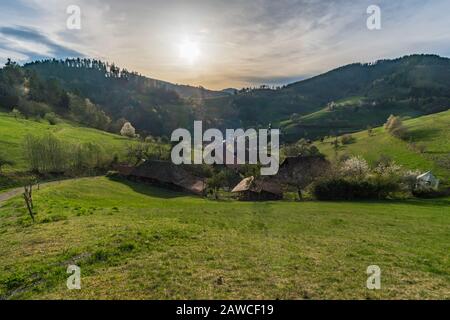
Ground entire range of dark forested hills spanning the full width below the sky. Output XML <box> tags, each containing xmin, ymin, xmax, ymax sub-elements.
<box><xmin>0</xmin><ymin>55</ymin><xmax>450</xmax><ymax>140</ymax></box>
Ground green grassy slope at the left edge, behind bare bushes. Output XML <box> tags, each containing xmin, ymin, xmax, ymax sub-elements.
<box><xmin>0</xmin><ymin>113</ymin><xmax>129</xmax><ymax>171</ymax></box>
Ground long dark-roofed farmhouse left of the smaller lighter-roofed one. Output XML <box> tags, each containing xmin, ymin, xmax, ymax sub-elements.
<box><xmin>116</xmin><ymin>160</ymin><xmax>206</xmax><ymax>195</ymax></box>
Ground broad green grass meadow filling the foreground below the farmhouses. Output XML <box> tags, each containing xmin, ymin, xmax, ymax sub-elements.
<box><xmin>0</xmin><ymin>178</ymin><xmax>450</xmax><ymax>299</ymax></box>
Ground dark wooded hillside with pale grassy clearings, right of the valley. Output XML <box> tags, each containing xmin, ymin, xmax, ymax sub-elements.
<box><xmin>205</xmin><ymin>55</ymin><xmax>450</xmax><ymax>141</ymax></box>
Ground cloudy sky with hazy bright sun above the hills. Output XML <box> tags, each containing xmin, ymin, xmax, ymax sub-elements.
<box><xmin>0</xmin><ymin>0</ymin><xmax>450</xmax><ymax>89</ymax></box>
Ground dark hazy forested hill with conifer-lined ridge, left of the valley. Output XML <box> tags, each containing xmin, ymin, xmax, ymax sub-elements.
<box><xmin>24</xmin><ymin>59</ymin><xmax>228</xmax><ymax>136</ymax></box>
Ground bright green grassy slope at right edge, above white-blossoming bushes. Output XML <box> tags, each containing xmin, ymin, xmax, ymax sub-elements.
<box><xmin>317</xmin><ymin>110</ymin><xmax>450</xmax><ymax>182</ymax></box>
